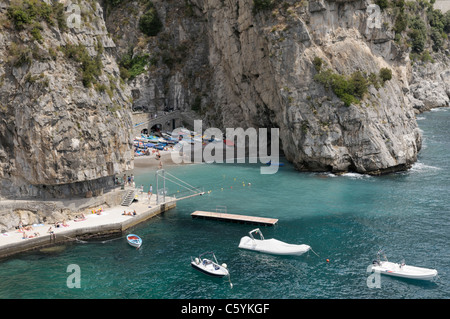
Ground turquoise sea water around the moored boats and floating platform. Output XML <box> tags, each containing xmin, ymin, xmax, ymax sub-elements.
<box><xmin>0</xmin><ymin>108</ymin><xmax>450</xmax><ymax>299</ymax></box>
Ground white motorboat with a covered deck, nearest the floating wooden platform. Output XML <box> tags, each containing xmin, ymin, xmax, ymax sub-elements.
<box><xmin>239</xmin><ymin>228</ymin><xmax>311</xmax><ymax>256</ymax></box>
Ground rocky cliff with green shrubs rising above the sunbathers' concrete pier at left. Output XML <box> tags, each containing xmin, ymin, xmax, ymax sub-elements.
<box><xmin>0</xmin><ymin>1</ymin><xmax>133</xmax><ymax>198</ymax></box>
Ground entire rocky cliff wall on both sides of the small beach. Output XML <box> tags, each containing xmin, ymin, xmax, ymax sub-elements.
<box><xmin>0</xmin><ymin>0</ymin><xmax>448</xmax><ymax>205</ymax></box>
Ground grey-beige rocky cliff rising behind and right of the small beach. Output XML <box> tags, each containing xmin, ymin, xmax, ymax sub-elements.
<box><xmin>111</xmin><ymin>0</ymin><xmax>421</xmax><ymax>174</ymax></box>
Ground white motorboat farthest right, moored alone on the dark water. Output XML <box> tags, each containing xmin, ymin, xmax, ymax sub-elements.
<box><xmin>371</xmin><ymin>251</ymin><xmax>437</xmax><ymax>280</ymax></box>
